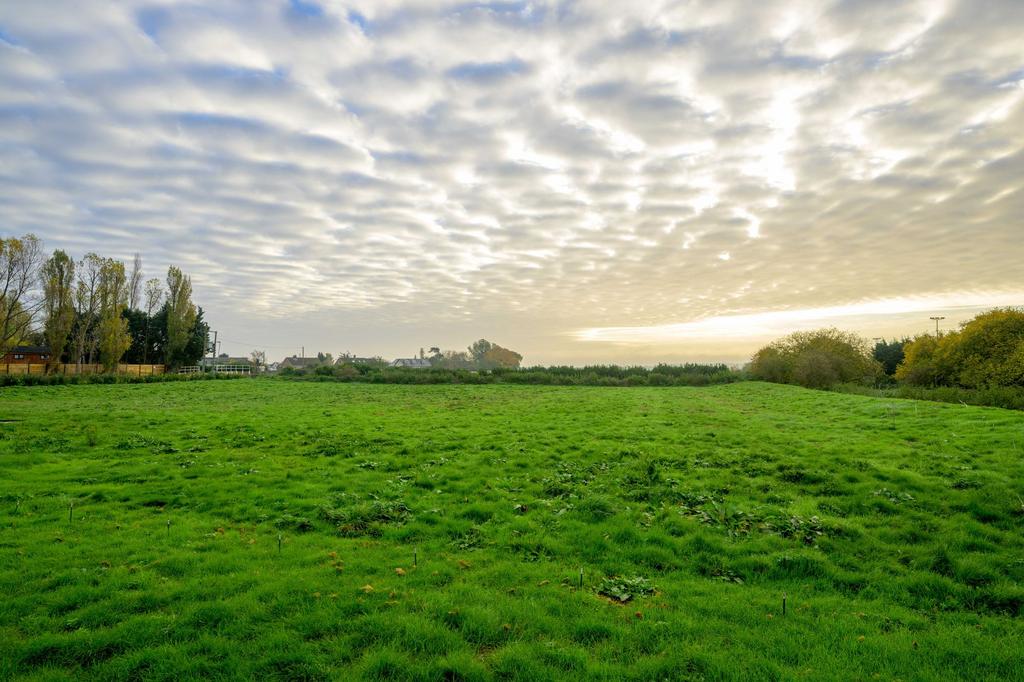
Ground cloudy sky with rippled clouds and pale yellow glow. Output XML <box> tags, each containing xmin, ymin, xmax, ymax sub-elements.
<box><xmin>0</xmin><ymin>0</ymin><xmax>1024</xmax><ymax>365</ymax></box>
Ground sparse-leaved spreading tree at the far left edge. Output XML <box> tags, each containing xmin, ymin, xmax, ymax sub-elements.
<box><xmin>0</xmin><ymin>235</ymin><xmax>42</xmax><ymax>355</ymax></box>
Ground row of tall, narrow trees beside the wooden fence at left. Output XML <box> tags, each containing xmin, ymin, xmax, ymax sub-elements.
<box><xmin>0</xmin><ymin>235</ymin><xmax>209</xmax><ymax>372</ymax></box>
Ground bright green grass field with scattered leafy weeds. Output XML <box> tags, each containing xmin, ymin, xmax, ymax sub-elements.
<box><xmin>0</xmin><ymin>380</ymin><xmax>1024</xmax><ymax>680</ymax></box>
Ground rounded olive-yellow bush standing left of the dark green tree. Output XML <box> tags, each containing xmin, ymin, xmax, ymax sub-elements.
<box><xmin>751</xmin><ymin>328</ymin><xmax>882</xmax><ymax>388</ymax></box>
